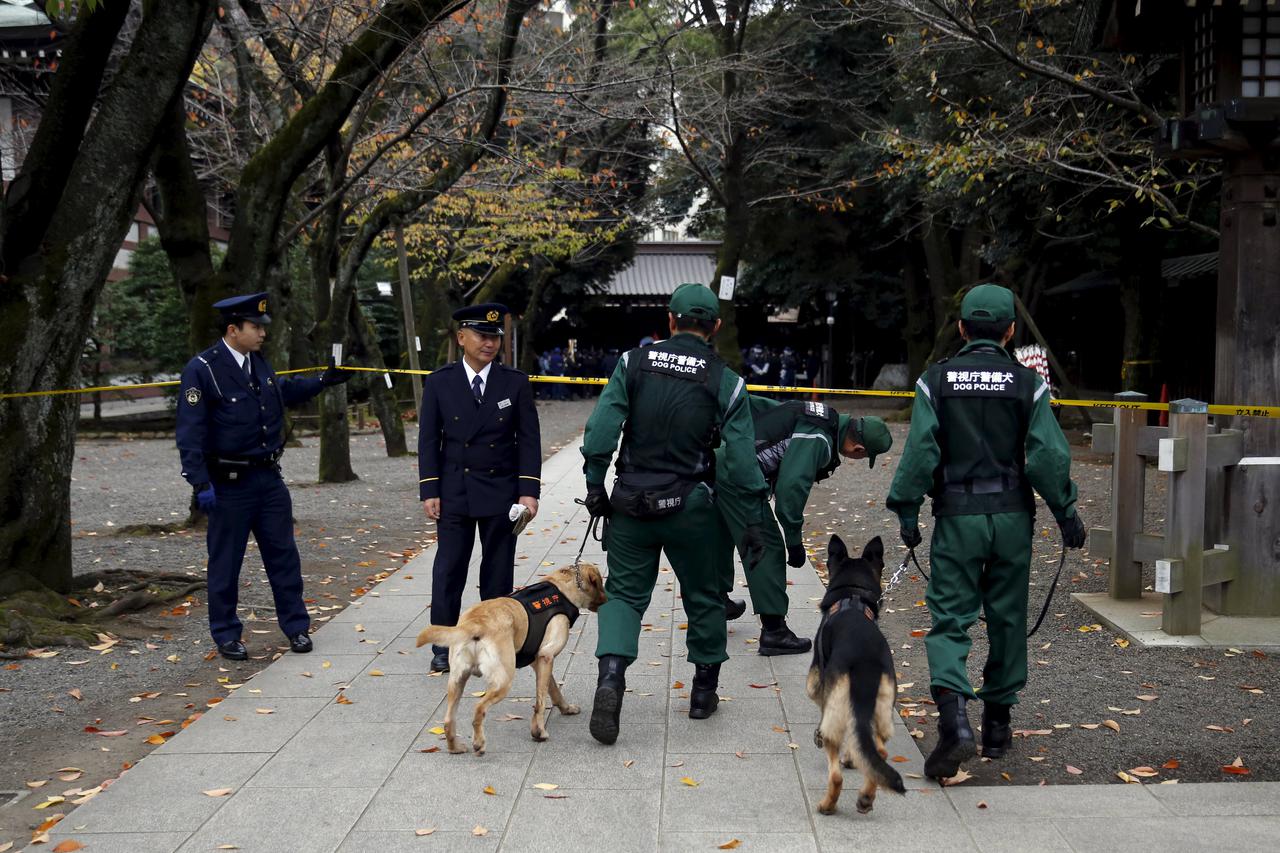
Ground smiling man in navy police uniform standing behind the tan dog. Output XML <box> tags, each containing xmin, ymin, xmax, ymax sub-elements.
<box><xmin>417</xmin><ymin>302</ymin><xmax>543</xmax><ymax>672</ymax></box>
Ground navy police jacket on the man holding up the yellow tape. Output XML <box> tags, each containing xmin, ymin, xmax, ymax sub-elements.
<box><xmin>177</xmin><ymin>341</ymin><xmax>324</xmax><ymax>485</ymax></box>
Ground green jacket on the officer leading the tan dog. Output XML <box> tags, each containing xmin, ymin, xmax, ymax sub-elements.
<box><xmin>582</xmin><ymin>333</ymin><xmax>769</xmax><ymax>507</ymax></box>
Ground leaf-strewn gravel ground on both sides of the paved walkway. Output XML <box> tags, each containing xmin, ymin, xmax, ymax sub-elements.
<box><xmin>0</xmin><ymin>401</ymin><xmax>1280</xmax><ymax>845</ymax></box>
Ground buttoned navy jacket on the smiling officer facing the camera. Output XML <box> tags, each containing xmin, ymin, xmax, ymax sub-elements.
<box><xmin>417</xmin><ymin>361</ymin><xmax>543</xmax><ymax>517</ymax></box>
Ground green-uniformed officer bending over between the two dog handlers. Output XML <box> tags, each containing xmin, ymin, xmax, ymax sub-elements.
<box><xmin>716</xmin><ymin>394</ymin><xmax>893</xmax><ymax>656</ymax></box>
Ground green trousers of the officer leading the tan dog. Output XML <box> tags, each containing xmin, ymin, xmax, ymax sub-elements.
<box><xmin>595</xmin><ymin>485</ymin><xmax>728</xmax><ymax>663</ymax></box>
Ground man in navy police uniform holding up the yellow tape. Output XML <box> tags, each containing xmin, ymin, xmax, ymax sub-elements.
<box><xmin>177</xmin><ymin>293</ymin><xmax>351</xmax><ymax>661</ymax></box>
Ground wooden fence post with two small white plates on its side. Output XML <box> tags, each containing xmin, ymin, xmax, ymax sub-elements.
<box><xmin>1156</xmin><ymin>400</ymin><xmax>1208</xmax><ymax>635</ymax></box>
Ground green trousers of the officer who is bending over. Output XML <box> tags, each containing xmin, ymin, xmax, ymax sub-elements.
<box><xmin>716</xmin><ymin>487</ymin><xmax>787</xmax><ymax>616</ymax></box>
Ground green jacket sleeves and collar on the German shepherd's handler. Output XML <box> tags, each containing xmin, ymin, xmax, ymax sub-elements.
<box><xmin>886</xmin><ymin>341</ymin><xmax>1076</xmax><ymax>526</ymax></box>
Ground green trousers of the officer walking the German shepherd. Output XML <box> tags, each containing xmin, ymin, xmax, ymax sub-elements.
<box><xmin>924</xmin><ymin>512</ymin><xmax>1032</xmax><ymax>704</ymax></box>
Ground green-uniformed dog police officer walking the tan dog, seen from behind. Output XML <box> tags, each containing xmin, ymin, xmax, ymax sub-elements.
<box><xmin>582</xmin><ymin>284</ymin><xmax>767</xmax><ymax>744</ymax></box>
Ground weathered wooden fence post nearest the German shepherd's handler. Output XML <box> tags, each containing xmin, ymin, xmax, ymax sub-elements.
<box><xmin>1107</xmin><ymin>391</ymin><xmax>1147</xmax><ymax>598</ymax></box>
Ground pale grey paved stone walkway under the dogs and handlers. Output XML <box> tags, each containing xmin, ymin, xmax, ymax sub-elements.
<box><xmin>40</xmin><ymin>446</ymin><xmax>1280</xmax><ymax>853</ymax></box>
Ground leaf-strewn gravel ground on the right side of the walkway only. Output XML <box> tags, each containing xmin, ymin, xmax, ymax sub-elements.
<box><xmin>792</xmin><ymin>409</ymin><xmax>1280</xmax><ymax>785</ymax></box>
